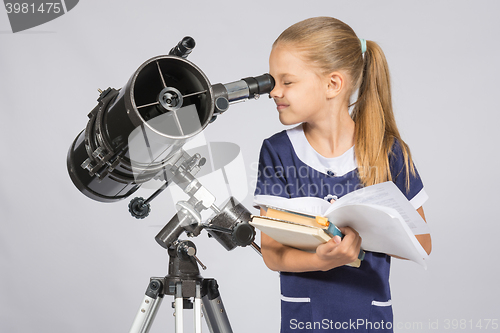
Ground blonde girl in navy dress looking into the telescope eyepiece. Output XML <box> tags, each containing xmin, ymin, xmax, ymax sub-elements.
<box><xmin>255</xmin><ymin>17</ymin><xmax>431</xmax><ymax>333</ymax></box>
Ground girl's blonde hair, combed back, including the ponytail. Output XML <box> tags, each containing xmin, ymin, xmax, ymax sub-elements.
<box><xmin>273</xmin><ymin>17</ymin><xmax>415</xmax><ymax>190</ymax></box>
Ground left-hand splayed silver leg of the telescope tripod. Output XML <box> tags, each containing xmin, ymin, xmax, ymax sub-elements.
<box><xmin>129</xmin><ymin>280</ymin><xmax>163</xmax><ymax>333</ymax></box>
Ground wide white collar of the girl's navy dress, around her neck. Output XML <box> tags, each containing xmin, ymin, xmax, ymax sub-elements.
<box><xmin>286</xmin><ymin>124</ymin><xmax>357</xmax><ymax>177</ymax></box>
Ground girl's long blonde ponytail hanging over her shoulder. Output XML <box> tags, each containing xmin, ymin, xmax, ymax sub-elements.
<box><xmin>351</xmin><ymin>41</ymin><xmax>415</xmax><ymax>189</ymax></box>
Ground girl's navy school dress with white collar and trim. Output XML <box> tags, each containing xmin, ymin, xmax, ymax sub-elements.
<box><xmin>255</xmin><ymin>125</ymin><xmax>427</xmax><ymax>333</ymax></box>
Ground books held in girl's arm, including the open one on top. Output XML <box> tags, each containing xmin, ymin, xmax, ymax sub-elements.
<box><xmin>250</xmin><ymin>182</ymin><xmax>429</xmax><ymax>267</ymax></box>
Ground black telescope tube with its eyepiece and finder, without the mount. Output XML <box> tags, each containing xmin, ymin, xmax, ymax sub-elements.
<box><xmin>67</xmin><ymin>37</ymin><xmax>274</xmax><ymax>202</ymax></box>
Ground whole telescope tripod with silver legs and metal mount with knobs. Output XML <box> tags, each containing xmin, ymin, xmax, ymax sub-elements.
<box><xmin>123</xmin><ymin>139</ymin><xmax>260</xmax><ymax>333</ymax></box>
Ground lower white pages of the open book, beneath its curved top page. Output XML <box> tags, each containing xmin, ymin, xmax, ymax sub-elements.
<box><xmin>326</xmin><ymin>204</ymin><xmax>428</xmax><ymax>267</ymax></box>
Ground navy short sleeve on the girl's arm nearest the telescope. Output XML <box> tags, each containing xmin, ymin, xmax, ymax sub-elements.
<box><xmin>254</xmin><ymin>140</ymin><xmax>290</xmax><ymax>198</ymax></box>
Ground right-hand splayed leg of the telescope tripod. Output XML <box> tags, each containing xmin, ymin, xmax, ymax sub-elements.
<box><xmin>203</xmin><ymin>279</ymin><xmax>233</xmax><ymax>333</ymax></box>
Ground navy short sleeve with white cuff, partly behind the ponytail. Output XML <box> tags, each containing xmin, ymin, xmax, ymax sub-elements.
<box><xmin>389</xmin><ymin>139</ymin><xmax>428</xmax><ymax>209</ymax></box>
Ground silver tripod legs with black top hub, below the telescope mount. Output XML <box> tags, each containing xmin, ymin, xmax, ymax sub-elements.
<box><xmin>129</xmin><ymin>241</ymin><xmax>233</xmax><ymax>333</ymax></box>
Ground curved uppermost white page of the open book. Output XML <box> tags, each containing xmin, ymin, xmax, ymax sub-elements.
<box><xmin>325</xmin><ymin>181</ymin><xmax>430</xmax><ymax>235</ymax></box>
